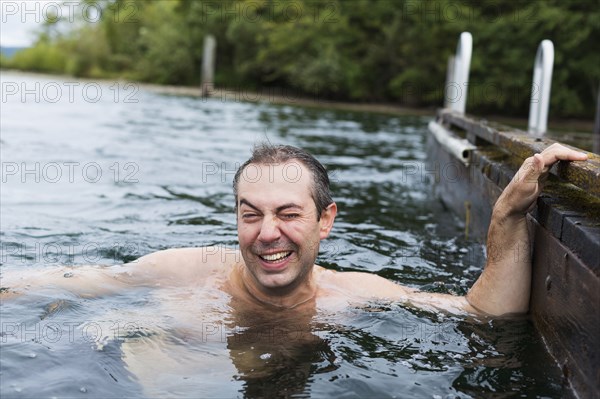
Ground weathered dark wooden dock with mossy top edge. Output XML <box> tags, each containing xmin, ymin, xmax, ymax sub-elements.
<box><xmin>428</xmin><ymin>109</ymin><xmax>600</xmax><ymax>398</ymax></box>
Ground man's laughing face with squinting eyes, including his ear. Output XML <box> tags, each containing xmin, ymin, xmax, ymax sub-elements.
<box><xmin>237</xmin><ymin>161</ymin><xmax>336</xmax><ymax>293</ymax></box>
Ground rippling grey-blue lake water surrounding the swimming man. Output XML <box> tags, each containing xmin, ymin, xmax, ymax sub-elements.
<box><xmin>0</xmin><ymin>71</ymin><xmax>569</xmax><ymax>398</ymax></box>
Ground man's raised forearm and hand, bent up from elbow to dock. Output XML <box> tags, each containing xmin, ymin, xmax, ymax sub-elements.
<box><xmin>466</xmin><ymin>144</ymin><xmax>587</xmax><ymax>316</ymax></box>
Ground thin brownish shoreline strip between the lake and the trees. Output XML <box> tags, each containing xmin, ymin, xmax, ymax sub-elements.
<box><xmin>0</xmin><ymin>69</ymin><xmax>594</xmax><ymax>135</ymax></box>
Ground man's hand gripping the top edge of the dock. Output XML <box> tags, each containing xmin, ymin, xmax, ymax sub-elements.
<box><xmin>495</xmin><ymin>143</ymin><xmax>587</xmax><ymax>216</ymax></box>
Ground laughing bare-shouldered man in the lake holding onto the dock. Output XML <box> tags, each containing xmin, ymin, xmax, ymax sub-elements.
<box><xmin>2</xmin><ymin>144</ymin><xmax>587</xmax><ymax>316</ymax></box>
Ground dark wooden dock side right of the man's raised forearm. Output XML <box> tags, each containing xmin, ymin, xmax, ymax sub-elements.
<box><xmin>531</xmin><ymin>222</ymin><xmax>600</xmax><ymax>398</ymax></box>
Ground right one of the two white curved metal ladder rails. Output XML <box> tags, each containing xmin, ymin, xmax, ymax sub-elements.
<box><xmin>527</xmin><ymin>40</ymin><xmax>554</xmax><ymax>136</ymax></box>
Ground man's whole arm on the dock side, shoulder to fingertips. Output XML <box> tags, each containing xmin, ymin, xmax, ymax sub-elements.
<box><xmin>333</xmin><ymin>144</ymin><xmax>587</xmax><ymax>316</ymax></box>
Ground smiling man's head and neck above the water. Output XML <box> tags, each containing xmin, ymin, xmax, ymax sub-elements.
<box><xmin>233</xmin><ymin>146</ymin><xmax>337</xmax><ymax>307</ymax></box>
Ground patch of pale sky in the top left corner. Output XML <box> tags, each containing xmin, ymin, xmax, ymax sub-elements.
<box><xmin>0</xmin><ymin>0</ymin><xmax>79</xmax><ymax>47</ymax></box>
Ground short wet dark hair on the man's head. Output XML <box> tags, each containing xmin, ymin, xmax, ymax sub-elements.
<box><xmin>233</xmin><ymin>143</ymin><xmax>333</xmax><ymax>220</ymax></box>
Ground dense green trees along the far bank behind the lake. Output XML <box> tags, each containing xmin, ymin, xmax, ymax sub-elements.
<box><xmin>0</xmin><ymin>0</ymin><xmax>600</xmax><ymax>118</ymax></box>
